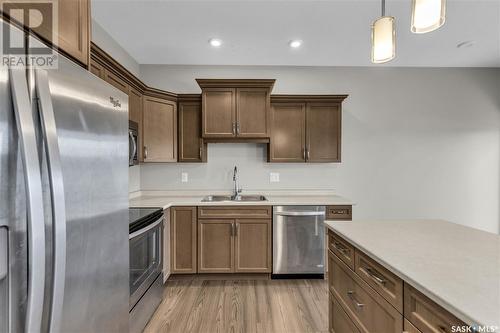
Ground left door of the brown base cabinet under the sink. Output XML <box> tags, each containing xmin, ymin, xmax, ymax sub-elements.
<box><xmin>198</xmin><ymin>219</ymin><xmax>235</xmax><ymax>273</ymax></box>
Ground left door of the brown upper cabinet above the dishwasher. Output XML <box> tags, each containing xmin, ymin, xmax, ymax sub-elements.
<box><xmin>269</xmin><ymin>103</ymin><xmax>306</xmax><ymax>162</ymax></box>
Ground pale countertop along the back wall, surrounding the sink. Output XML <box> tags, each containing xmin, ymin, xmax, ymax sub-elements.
<box><xmin>129</xmin><ymin>190</ymin><xmax>353</xmax><ymax>209</ymax></box>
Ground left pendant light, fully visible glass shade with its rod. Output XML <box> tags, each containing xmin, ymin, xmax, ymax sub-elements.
<box><xmin>371</xmin><ymin>0</ymin><xmax>396</xmax><ymax>64</ymax></box>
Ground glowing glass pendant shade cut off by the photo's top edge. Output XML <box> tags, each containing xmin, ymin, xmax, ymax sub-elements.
<box><xmin>411</xmin><ymin>0</ymin><xmax>446</xmax><ymax>34</ymax></box>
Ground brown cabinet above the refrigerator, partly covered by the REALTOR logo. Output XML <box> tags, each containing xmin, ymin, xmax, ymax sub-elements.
<box><xmin>0</xmin><ymin>0</ymin><xmax>90</xmax><ymax>67</ymax></box>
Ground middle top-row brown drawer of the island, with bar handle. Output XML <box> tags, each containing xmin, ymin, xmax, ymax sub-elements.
<box><xmin>354</xmin><ymin>249</ymin><xmax>403</xmax><ymax>313</ymax></box>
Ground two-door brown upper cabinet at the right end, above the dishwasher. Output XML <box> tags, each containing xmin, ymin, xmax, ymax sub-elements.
<box><xmin>268</xmin><ymin>95</ymin><xmax>347</xmax><ymax>162</ymax></box>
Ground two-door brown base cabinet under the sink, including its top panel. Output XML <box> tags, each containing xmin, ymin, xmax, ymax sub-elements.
<box><xmin>198</xmin><ymin>206</ymin><xmax>272</xmax><ymax>273</ymax></box>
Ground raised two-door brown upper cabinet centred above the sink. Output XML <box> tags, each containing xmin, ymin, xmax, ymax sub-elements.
<box><xmin>196</xmin><ymin>79</ymin><xmax>275</xmax><ymax>139</ymax></box>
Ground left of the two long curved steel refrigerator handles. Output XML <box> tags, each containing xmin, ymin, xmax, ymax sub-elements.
<box><xmin>9</xmin><ymin>69</ymin><xmax>45</xmax><ymax>332</ymax></box>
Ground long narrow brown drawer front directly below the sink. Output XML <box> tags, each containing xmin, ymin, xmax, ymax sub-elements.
<box><xmin>198</xmin><ymin>206</ymin><xmax>272</xmax><ymax>219</ymax></box>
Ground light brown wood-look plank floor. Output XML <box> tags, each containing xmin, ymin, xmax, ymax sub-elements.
<box><xmin>144</xmin><ymin>278</ymin><xmax>328</xmax><ymax>333</ymax></box>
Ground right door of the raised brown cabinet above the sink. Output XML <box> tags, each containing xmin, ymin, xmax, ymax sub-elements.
<box><xmin>236</xmin><ymin>88</ymin><xmax>270</xmax><ymax>138</ymax></box>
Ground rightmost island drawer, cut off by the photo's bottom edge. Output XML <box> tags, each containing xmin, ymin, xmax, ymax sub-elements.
<box><xmin>404</xmin><ymin>283</ymin><xmax>465</xmax><ymax>333</ymax></box>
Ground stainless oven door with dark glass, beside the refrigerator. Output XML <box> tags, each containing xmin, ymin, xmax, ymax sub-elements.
<box><xmin>129</xmin><ymin>217</ymin><xmax>163</xmax><ymax>310</ymax></box>
